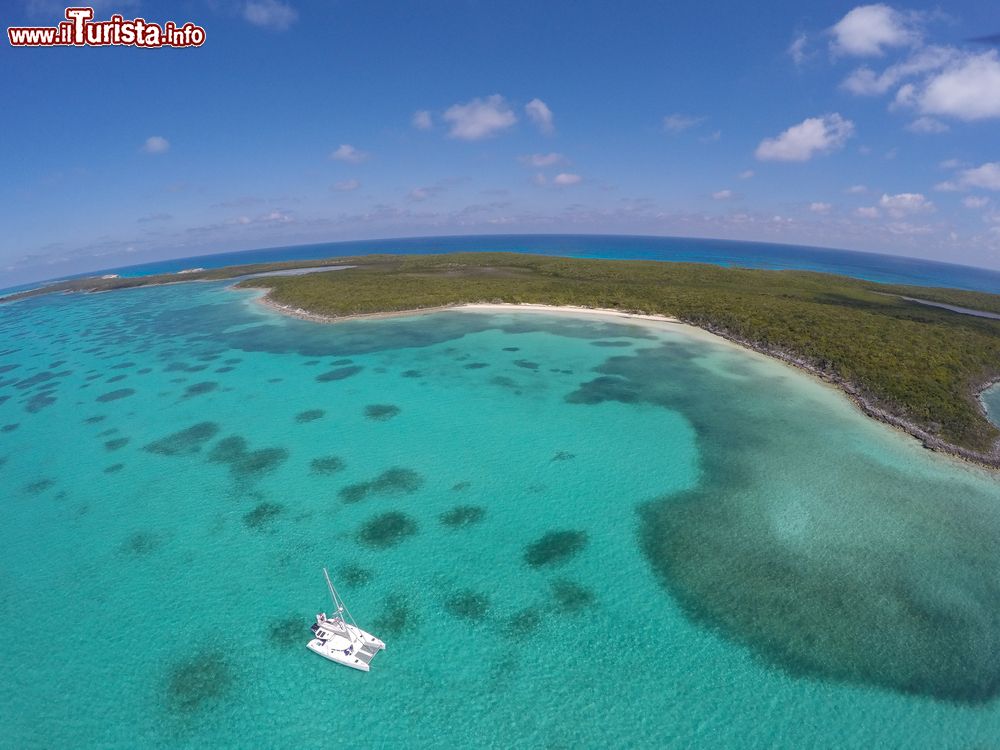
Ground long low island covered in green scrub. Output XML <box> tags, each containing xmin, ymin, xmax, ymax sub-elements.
<box><xmin>0</xmin><ymin>253</ymin><xmax>1000</xmax><ymax>468</ymax></box>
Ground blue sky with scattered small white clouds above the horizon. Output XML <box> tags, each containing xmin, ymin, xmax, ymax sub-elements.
<box><xmin>0</xmin><ymin>0</ymin><xmax>1000</xmax><ymax>286</ymax></box>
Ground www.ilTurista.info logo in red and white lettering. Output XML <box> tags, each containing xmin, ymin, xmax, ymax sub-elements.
<box><xmin>7</xmin><ymin>8</ymin><xmax>205</xmax><ymax>48</ymax></box>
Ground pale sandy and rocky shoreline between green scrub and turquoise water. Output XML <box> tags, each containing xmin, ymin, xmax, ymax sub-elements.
<box><xmin>250</xmin><ymin>287</ymin><xmax>1000</xmax><ymax>471</ymax></box>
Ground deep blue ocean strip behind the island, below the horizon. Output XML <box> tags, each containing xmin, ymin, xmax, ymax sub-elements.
<box><xmin>17</xmin><ymin>235</ymin><xmax>1000</xmax><ymax>294</ymax></box>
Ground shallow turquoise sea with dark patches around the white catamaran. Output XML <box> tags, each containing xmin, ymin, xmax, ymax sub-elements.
<box><xmin>0</xmin><ymin>284</ymin><xmax>1000</xmax><ymax>748</ymax></box>
